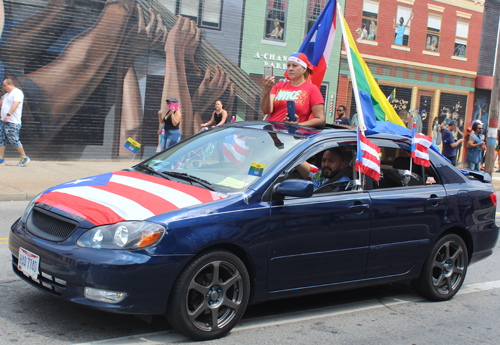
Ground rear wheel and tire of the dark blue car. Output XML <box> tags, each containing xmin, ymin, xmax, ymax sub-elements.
<box><xmin>411</xmin><ymin>234</ymin><xmax>469</xmax><ymax>301</ymax></box>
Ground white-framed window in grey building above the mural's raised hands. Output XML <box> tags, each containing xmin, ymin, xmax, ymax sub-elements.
<box><xmin>176</xmin><ymin>0</ymin><xmax>222</xmax><ymax>29</ymax></box>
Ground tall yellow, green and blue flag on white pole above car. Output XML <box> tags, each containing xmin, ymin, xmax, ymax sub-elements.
<box><xmin>337</xmin><ymin>4</ymin><xmax>404</xmax><ymax>131</ymax></box>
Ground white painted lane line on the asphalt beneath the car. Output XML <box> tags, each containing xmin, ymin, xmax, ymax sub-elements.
<box><xmin>77</xmin><ymin>280</ymin><xmax>500</xmax><ymax>345</ymax></box>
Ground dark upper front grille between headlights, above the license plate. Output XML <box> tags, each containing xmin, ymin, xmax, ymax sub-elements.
<box><xmin>27</xmin><ymin>208</ymin><xmax>78</xmax><ymax>242</ymax></box>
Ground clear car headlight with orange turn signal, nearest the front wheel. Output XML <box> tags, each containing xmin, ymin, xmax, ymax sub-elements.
<box><xmin>76</xmin><ymin>221</ymin><xmax>165</xmax><ymax>249</ymax></box>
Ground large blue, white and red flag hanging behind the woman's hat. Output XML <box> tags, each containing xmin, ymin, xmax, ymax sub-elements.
<box><xmin>299</xmin><ymin>0</ymin><xmax>337</xmax><ymax>88</ymax></box>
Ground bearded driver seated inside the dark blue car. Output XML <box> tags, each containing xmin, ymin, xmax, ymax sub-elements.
<box><xmin>297</xmin><ymin>148</ymin><xmax>351</xmax><ymax>191</ymax></box>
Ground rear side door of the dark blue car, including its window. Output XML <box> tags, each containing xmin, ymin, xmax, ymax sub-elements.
<box><xmin>365</xmin><ymin>141</ymin><xmax>447</xmax><ymax>279</ymax></box>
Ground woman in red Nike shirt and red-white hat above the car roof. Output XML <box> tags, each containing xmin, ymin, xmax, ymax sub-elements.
<box><xmin>260</xmin><ymin>53</ymin><xmax>325</xmax><ymax>127</ymax></box>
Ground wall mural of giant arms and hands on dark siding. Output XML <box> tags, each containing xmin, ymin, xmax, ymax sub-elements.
<box><xmin>0</xmin><ymin>0</ymin><xmax>262</xmax><ymax>159</ymax></box>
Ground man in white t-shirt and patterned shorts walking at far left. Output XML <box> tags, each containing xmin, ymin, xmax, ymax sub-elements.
<box><xmin>0</xmin><ymin>78</ymin><xmax>30</xmax><ymax>166</ymax></box>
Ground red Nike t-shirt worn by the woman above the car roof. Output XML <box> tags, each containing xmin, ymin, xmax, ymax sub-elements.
<box><xmin>267</xmin><ymin>81</ymin><xmax>325</xmax><ymax>122</ymax></box>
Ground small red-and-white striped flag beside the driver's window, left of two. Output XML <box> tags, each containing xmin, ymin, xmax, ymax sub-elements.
<box><xmin>355</xmin><ymin>127</ymin><xmax>380</xmax><ymax>181</ymax></box>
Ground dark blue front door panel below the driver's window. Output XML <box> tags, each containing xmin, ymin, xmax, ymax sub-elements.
<box><xmin>268</xmin><ymin>140</ymin><xmax>371</xmax><ymax>291</ymax></box>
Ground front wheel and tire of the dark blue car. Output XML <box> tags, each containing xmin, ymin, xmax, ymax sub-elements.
<box><xmin>166</xmin><ymin>250</ymin><xmax>250</xmax><ymax>340</ymax></box>
